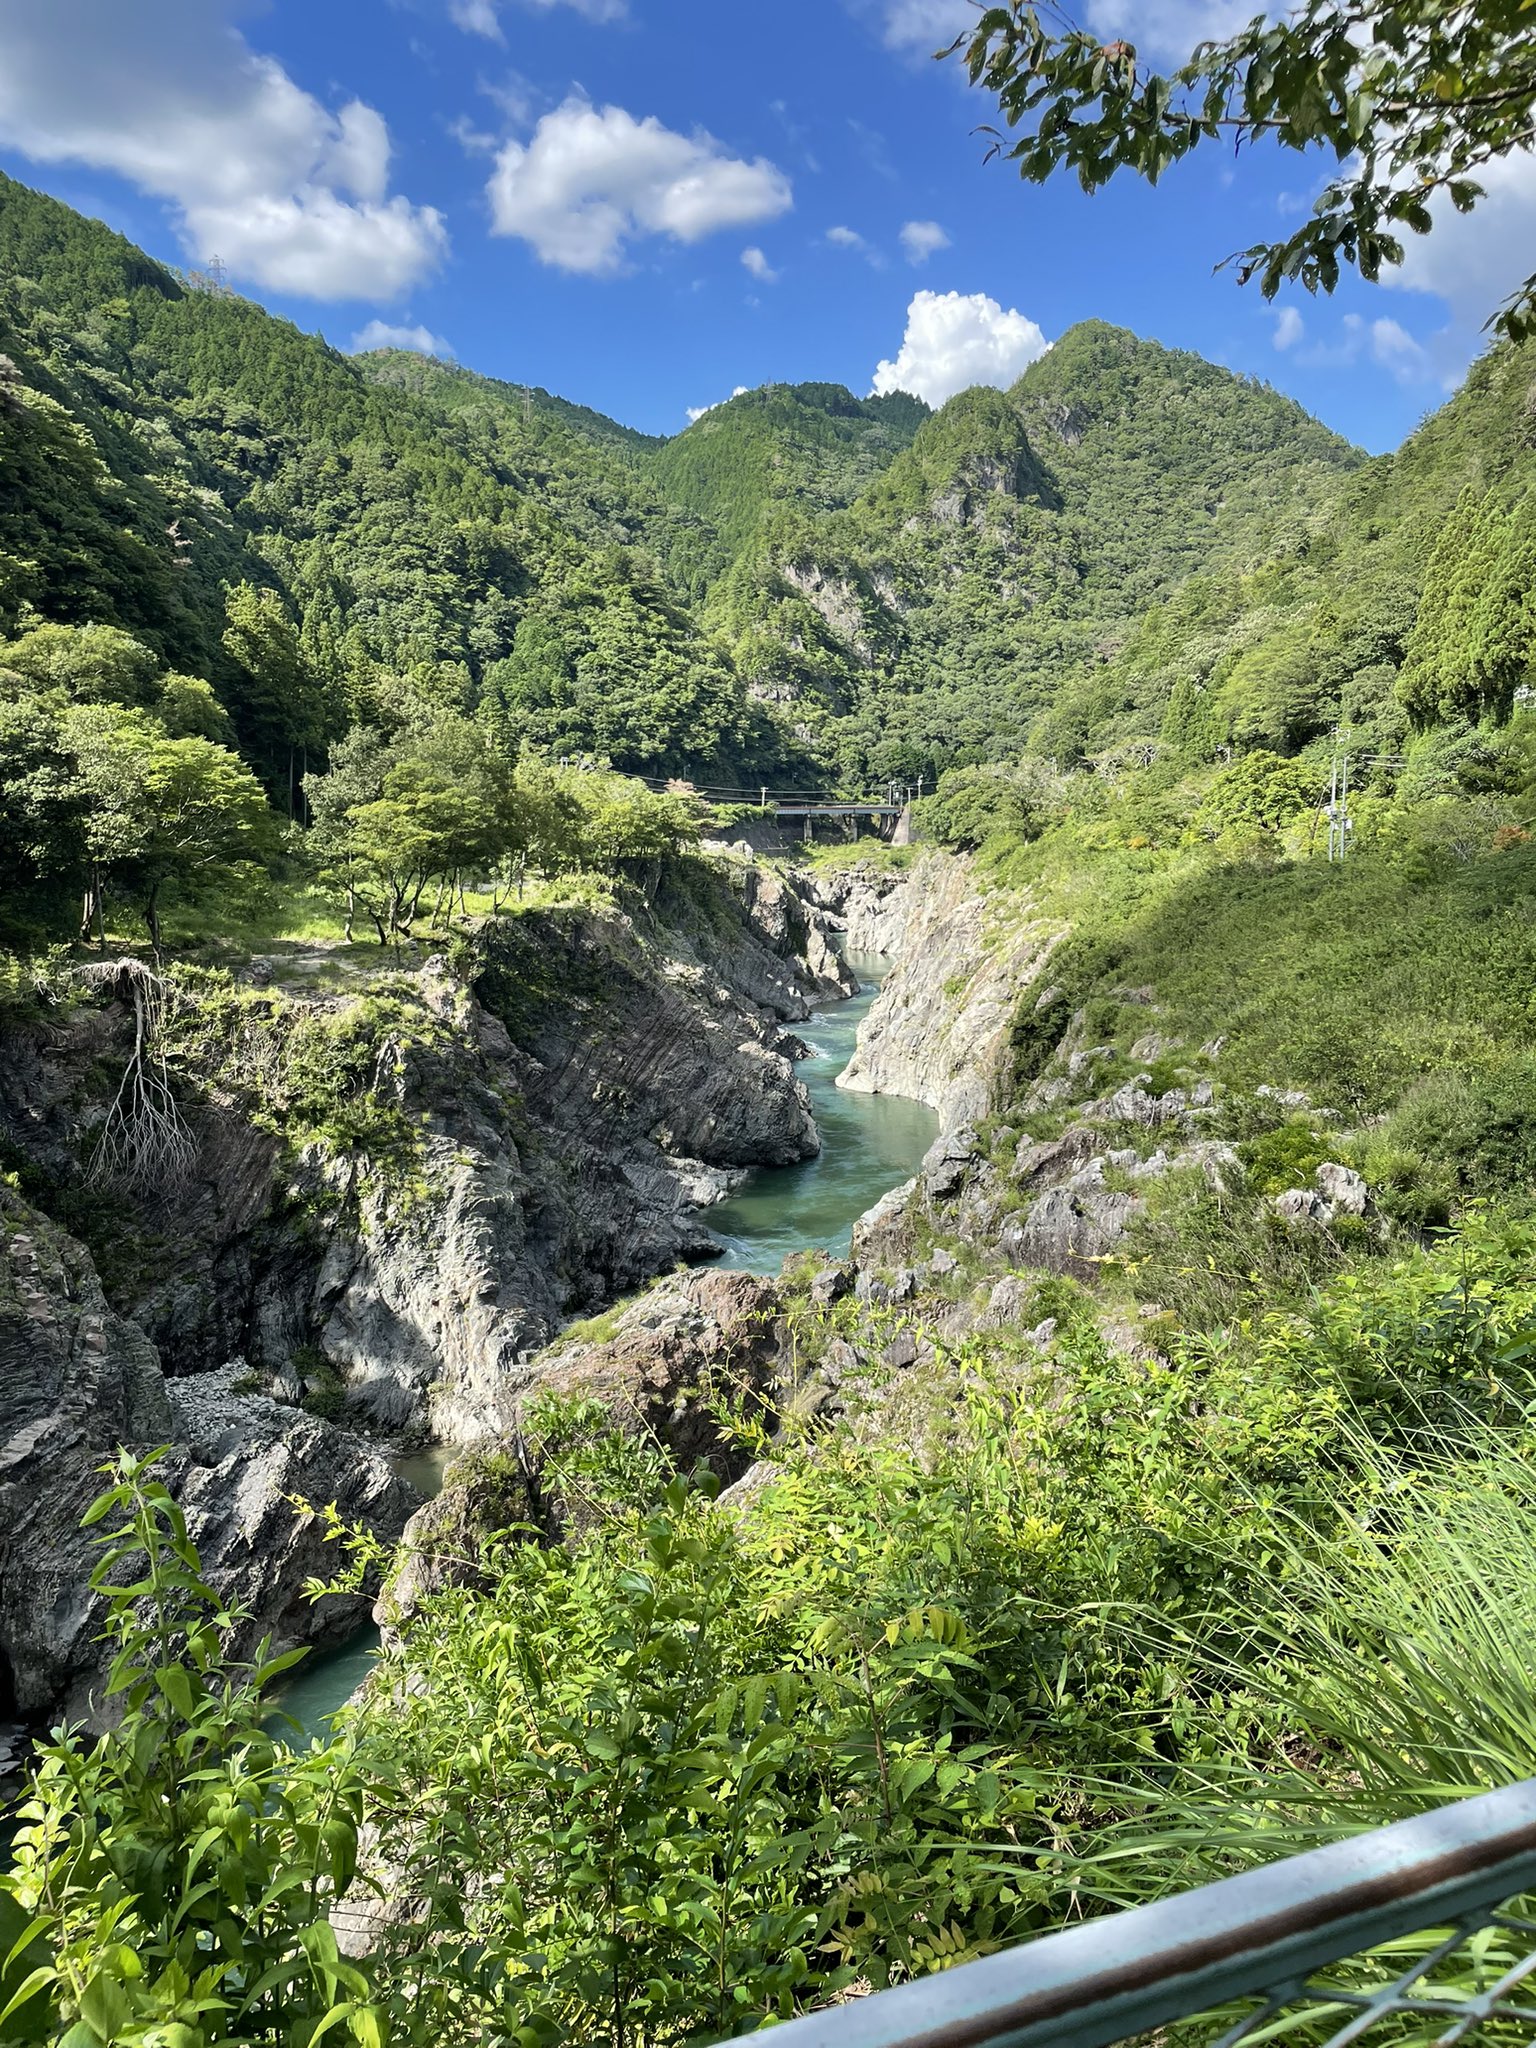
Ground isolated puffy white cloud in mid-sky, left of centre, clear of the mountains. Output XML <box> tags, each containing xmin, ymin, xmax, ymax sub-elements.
<box><xmin>487</xmin><ymin>98</ymin><xmax>795</xmax><ymax>276</ymax></box>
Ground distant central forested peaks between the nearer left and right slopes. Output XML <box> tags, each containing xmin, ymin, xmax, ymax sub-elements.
<box><xmin>387</xmin><ymin>322</ymin><xmax>1360</xmax><ymax>782</ymax></box>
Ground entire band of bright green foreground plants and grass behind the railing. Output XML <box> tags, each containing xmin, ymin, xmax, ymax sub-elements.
<box><xmin>20</xmin><ymin>1221</ymin><xmax>1536</xmax><ymax>2048</ymax></box>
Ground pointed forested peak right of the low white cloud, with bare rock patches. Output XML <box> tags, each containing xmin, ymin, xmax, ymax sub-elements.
<box><xmin>696</xmin><ymin>322</ymin><xmax>1362</xmax><ymax>778</ymax></box>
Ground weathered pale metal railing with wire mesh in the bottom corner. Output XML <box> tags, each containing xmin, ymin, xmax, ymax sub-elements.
<box><xmin>749</xmin><ymin>1778</ymin><xmax>1536</xmax><ymax>2048</ymax></box>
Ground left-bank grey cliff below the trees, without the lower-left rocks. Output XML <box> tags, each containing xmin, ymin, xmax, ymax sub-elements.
<box><xmin>0</xmin><ymin>862</ymin><xmax>850</xmax><ymax>1442</ymax></box>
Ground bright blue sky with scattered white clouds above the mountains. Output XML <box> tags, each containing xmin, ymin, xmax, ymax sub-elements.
<box><xmin>0</xmin><ymin>0</ymin><xmax>1536</xmax><ymax>451</ymax></box>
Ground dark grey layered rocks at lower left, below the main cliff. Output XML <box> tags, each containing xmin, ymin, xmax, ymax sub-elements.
<box><xmin>0</xmin><ymin>1186</ymin><xmax>420</xmax><ymax>1716</ymax></box>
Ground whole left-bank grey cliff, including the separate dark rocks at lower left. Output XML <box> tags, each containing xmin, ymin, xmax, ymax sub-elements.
<box><xmin>0</xmin><ymin>864</ymin><xmax>846</xmax><ymax>1714</ymax></box>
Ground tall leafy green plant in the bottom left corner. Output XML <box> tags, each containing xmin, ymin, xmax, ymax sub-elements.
<box><xmin>0</xmin><ymin>1452</ymin><xmax>385</xmax><ymax>2048</ymax></box>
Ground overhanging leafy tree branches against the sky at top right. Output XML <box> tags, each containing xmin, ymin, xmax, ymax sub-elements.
<box><xmin>954</xmin><ymin>0</ymin><xmax>1536</xmax><ymax>338</ymax></box>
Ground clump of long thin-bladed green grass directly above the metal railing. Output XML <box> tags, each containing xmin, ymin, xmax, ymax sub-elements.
<box><xmin>1069</xmin><ymin>1421</ymin><xmax>1536</xmax><ymax>1905</ymax></box>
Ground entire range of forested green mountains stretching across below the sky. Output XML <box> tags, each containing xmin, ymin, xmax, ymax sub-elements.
<box><xmin>0</xmin><ymin>161</ymin><xmax>1532</xmax><ymax>803</ymax></box>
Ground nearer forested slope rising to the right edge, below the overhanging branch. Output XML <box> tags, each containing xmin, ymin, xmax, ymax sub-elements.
<box><xmin>1034</xmin><ymin>331</ymin><xmax>1536</xmax><ymax>762</ymax></box>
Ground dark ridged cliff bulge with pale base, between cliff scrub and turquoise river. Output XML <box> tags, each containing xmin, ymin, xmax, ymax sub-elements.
<box><xmin>311</xmin><ymin>920</ymin><xmax>819</xmax><ymax>1442</ymax></box>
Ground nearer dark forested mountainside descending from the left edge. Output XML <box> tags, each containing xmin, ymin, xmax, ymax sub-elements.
<box><xmin>0</xmin><ymin>180</ymin><xmax>786</xmax><ymax>782</ymax></box>
